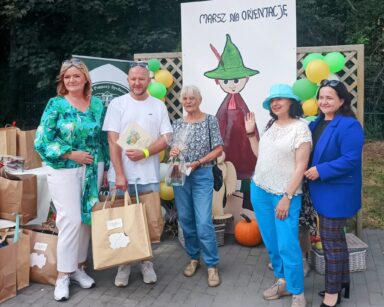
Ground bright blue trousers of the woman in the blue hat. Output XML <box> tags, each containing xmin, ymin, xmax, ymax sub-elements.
<box><xmin>251</xmin><ymin>181</ymin><xmax>304</xmax><ymax>294</ymax></box>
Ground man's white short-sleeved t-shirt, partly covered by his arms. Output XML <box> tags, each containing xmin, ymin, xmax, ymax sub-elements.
<box><xmin>103</xmin><ymin>94</ymin><xmax>172</xmax><ymax>184</ymax></box>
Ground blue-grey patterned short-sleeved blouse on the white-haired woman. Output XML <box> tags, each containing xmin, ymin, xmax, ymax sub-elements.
<box><xmin>172</xmin><ymin>114</ymin><xmax>223</xmax><ymax>166</ymax></box>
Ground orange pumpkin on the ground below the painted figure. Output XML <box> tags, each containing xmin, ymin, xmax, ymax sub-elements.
<box><xmin>235</xmin><ymin>213</ymin><xmax>261</xmax><ymax>246</ymax></box>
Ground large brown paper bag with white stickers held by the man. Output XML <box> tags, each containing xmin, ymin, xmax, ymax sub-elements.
<box><xmin>92</xmin><ymin>193</ymin><xmax>152</xmax><ymax>270</ymax></box>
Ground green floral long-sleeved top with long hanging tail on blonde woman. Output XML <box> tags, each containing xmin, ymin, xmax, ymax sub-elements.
<box><xmin>35</xmin><ymin>96</ymin><xmax>109</xmax><ymax>224</ymax></box>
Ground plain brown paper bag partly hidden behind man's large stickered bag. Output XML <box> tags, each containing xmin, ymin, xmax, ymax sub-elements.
<box><xmin>132</xmin><ymin>192</ymin><xmax>164</xmax><ymax>243</ymax></box>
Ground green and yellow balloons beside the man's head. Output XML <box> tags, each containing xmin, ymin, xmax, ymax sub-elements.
<box><xmin>148</xmin><ymin>59</ymin><xmax>173</xmax><ymax>100</ymax></box>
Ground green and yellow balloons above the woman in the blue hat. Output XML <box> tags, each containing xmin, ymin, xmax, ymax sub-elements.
<box><xmin>293</xmin><ymin>52</ymin><xmax>345</xmax><ymax>122</ymax></box>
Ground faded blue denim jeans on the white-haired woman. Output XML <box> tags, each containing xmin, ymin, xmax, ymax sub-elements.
<box><xmin>173</xmin><ymin>167</ymin><xmax>219</xmax><ymax>267</ymax></box>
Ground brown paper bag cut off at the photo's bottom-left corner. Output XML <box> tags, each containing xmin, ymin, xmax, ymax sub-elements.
<box><xmin>0</xmin><ymin>237</ymin><xmax>16</xmax><ymax>303</ymax></box>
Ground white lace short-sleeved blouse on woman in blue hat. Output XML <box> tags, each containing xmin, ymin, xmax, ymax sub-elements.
<box><xmin>253</xmin><ymin>120</ymin><xmax>312</xmax><ymax>195</ymax></box>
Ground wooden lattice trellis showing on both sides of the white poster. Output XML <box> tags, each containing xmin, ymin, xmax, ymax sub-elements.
<box><xmin>134</xmin><ymin>45</ymin><xmax>364</xmax><ymax>236</ymax></box>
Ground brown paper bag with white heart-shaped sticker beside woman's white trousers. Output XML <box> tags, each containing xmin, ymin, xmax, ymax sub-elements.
<box><xmin>26</xmin><ymin>225</ymin><xmax>57</xmax><ymax>285</ymax></box>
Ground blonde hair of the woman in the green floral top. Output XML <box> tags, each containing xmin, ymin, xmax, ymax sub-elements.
<box><xmin>56</xmin><ymin>58</ymin><xmax>92</xmax><ymax>97</ymax></box>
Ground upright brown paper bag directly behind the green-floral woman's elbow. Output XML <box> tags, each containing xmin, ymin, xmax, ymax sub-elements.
<box><xmin>16</xmin><ymin>129</ymin><xmax>41</xmax><ymax>169</ymax></box>
